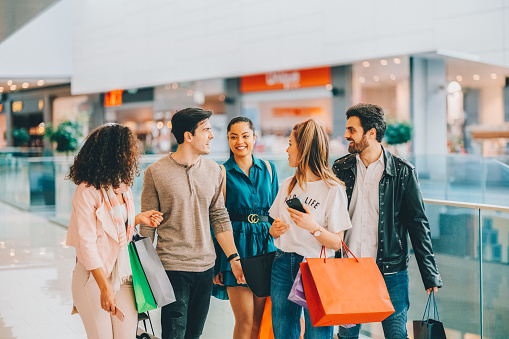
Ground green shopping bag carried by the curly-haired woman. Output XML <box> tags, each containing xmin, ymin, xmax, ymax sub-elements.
<box><xmin>128</xmin><ymin>243</ymin><xmax>157</xmax><ymax>313</ymax></box>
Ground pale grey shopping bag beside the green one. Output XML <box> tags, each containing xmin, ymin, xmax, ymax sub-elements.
<box><xmin>132</xmin><ymin>234</ymin><xmax>176</xmax><ymax>307</ymax></box>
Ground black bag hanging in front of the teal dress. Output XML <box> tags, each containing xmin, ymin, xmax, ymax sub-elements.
<box><xmin>240</xmin><ymin>233</ymin><xmax>276</xmax><ymax>298</ymax></box>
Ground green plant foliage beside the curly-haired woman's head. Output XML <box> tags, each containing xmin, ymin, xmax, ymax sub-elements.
<box><xmin>45</xmin><ymin>121</ymin><xmax>83</xmax><ymax>153</ymax></box>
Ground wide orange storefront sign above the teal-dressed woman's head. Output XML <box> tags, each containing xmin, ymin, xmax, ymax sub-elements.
<box><xmin>240</xmin><ymin>67</ymin><xmax>331</xmax><ymax>93</ymax></box>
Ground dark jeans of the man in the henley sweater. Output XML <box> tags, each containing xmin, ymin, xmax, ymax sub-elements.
<box><xmin>161</xmin><ymin>268</ymin><xmax>214</xmax><ymax>339</ymax></box>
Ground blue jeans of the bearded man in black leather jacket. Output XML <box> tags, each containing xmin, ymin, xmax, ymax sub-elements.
<box><xmin>338</xmin><ymin>270</ymin><xmax>410</xmax><ymax>339</ymax></box>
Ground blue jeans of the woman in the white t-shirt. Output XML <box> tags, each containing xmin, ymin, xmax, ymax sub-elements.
<box><xmin>270</xmin><ymin>250</ymin><xmax>334</xmax><ymax>339</ymax></box>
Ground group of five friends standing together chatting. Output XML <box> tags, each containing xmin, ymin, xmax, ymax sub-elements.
<box><xmin>67</xmin><ymin>104</ymin><xmax>442</xmax><ymax>339</ymax></box>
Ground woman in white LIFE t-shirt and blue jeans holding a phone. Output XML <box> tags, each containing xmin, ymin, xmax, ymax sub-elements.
<box><xmin>269</xmin><ymin>119</ymin><xmax>352</xmax><ymax>339</ymax></box>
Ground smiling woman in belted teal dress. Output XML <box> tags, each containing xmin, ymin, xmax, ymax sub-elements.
<box><xmin>213</xmin><ymin>117</ymin><xmax>279</xmax><ymax>339</ymax></box>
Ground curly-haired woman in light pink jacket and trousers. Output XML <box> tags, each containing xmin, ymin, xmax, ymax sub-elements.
<box><xmin>67</xmin><ymin>124</ymin><xmax>162</xmax><ymax>339</ymax></box>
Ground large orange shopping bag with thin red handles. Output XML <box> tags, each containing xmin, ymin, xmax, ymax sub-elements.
<box><xmin>300</xmin><ymin>243</ymin><xmax>394</xmax><ymax>326</ymax></box>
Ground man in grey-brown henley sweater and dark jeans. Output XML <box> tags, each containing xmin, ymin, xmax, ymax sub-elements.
<box><xmin>141</xmin><ymin>108</ymin><xmax>245</xmax><ymax>339</ymax></box>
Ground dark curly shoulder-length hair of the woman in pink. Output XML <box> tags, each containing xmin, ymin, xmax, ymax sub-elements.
<box><xmin>66</xmin><ymin>124</ymin><xmax>140</xmax><ymax>189</ymax></box>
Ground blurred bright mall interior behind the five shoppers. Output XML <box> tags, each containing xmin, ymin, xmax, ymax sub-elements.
<box><xmin>0</xmin><ymin>0</ymin><xmax>509</xmax><ymax>339</ymax></box>
